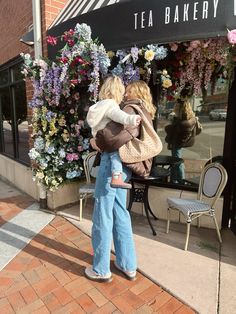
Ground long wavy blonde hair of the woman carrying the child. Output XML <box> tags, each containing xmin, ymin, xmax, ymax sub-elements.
<box><xmin>126</xmin><ymin>81</ymin><xmax>156</xmax><ymax>119</ymax></box>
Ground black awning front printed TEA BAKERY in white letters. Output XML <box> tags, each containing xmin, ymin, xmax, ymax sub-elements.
<box><xmin>48</xmin><ymin>0</ymin><xmax>236</xmax><ymax>57</ymax></box>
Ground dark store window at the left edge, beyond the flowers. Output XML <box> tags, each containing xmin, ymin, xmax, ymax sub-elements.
<box><xmin>0</xmin><ymin>59</ymin><xmax>29</xmax><ymax>164</ymax></box>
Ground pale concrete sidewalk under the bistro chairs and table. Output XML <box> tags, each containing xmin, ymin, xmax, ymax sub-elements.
<box><xmin>58</xmin><ymin>202</ymin><xmax>236</xmax><ymax>314</ymax></box>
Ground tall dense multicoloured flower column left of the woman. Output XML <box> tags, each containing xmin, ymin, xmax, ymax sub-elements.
<box><xmin>22</xmin><ymin>24</ymin><xmax>110</xmax><ymax>190</ymax></box>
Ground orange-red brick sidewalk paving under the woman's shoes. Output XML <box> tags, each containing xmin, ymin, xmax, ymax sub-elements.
<box><xmin>0</xmin><ymin>196</ymin><xmax>194</xmax><ymax>314</ymax></box>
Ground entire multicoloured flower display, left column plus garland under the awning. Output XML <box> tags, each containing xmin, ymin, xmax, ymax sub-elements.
<box><xmin>22</xmin><ymin>24</ymin><xmax>234</xmax><ymax>190</ymax></box>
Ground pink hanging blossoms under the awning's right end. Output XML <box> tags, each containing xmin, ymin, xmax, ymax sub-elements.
<box><xmin>170</xmin><ymin>37</ymin><xmax>229</xmax><ymax>95</ymax></box>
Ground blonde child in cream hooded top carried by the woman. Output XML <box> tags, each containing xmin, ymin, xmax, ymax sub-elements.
<box><xmin>87</xmin><ymin>75</ymin><xmax>141</xmax><ymax>189</ymax></box>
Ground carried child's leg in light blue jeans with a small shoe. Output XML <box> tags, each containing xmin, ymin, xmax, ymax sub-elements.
<box><xmin>109</xmin><ymin>151</ymin><xmax>131</xmax><ymax>189</ymax></box>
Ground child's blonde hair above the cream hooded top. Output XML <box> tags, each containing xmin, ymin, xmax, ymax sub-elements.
<box><xmin>98</xmin><ymin>75</ymin><xmax>125</xmax><ymax>104</ymax></box>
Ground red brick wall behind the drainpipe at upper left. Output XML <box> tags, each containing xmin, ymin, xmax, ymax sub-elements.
<box><xmin>0</xmin><ymin>0</ymin><xmax>68</xmax><ymax>152</ymax></box>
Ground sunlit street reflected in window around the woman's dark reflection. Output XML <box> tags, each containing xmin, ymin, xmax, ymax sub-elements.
<box><xmin>158</xmin><ymin>79</ymin><xmax>228</xmax><ymax>184</ymax></box>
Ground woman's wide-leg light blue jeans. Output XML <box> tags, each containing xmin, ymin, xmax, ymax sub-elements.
<box><xmin>92</xmin><ymin>153</ymin><xmax>137</xmax><ymax>275</ymax></box>
